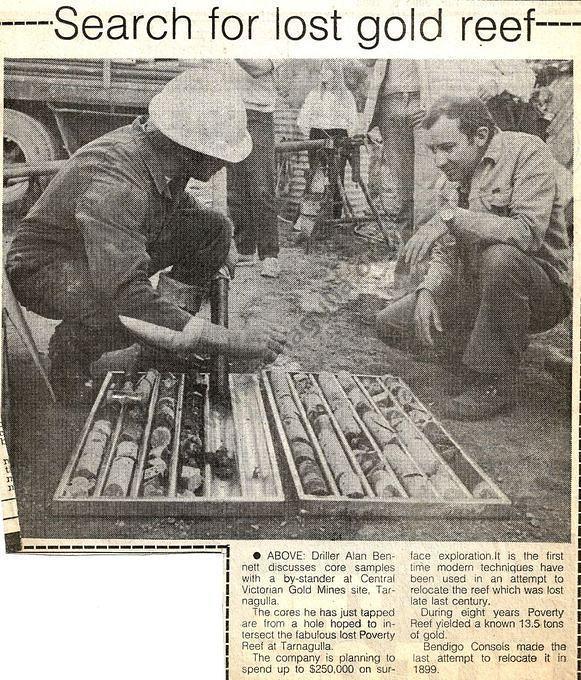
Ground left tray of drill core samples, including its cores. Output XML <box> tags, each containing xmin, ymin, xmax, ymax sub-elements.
<box><xmin>52</xmin><ymin>370</ymin><xmax>284</xmax><ymax>516</ymax></box>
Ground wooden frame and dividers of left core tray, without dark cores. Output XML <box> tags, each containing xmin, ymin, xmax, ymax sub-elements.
<box><xmin>52</xmin><ymin>372</ymin><xmax>284</xmax><ymax>516</ymax></box>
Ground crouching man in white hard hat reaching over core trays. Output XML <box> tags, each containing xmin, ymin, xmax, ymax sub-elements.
<box><xmin>6</xmin><ymin>72</ymin><xmax>284</xmax><ymax>401</ymax></box>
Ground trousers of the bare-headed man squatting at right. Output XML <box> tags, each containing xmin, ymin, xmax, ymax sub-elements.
<box><xmin>377</xmin><ymin>244</ymin><xmax>570</xmax><ymax>374</ymax></box>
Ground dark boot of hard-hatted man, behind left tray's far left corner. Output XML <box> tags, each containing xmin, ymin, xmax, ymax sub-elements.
<box><xmin>48</xmin><ymin>321</ymin><xmax>96</xmax><ymax>404</ymax></box>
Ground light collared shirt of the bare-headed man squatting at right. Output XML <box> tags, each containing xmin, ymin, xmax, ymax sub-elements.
<box><xmin>420</xmin><ymin>131</ymin><xmax>571</xmax><ymax>295</ymax></box>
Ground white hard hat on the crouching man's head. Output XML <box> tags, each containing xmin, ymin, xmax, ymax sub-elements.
<box><xmin>149</xmin><ymin>70</ymin><xmax>252</xmax><ymax>163</ymax></box>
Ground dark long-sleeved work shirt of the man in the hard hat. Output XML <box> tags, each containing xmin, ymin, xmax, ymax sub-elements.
<box><xmin>11</xmin><ymin>119</ymin><xmax>191</xmax><ymax>330</ymax></box>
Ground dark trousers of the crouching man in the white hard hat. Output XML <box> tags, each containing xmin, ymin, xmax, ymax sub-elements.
<box><xmin>7</xmin><ymin>206</ymin><xmax>231</xmax><ymax>362</ymax></box>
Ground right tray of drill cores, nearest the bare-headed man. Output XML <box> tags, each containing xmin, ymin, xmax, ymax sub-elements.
<box><xmin>263</xmin><ymin>370</ymin><xmax>511</xmax><ymax>517</ymax></box>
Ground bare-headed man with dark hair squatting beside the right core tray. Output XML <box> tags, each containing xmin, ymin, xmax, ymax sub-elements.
<box><xmin>377</xmin><ymin>98</ymin><xmax>571</xmax><ymax>420</ymax></box>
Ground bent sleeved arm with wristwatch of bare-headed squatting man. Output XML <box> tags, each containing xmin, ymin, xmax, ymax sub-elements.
<box><xmin>450</xmin><ymin>141</ymin><xmax>556</xmax><ymax>253</ymax></box>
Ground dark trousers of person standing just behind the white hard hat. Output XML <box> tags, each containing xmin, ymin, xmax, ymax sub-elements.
<box><xmin>228</xmin><ymin>109</ymin><xmax>279</xmax><ymax>260</ymax></box>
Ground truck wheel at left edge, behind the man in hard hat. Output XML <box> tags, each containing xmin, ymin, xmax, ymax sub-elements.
<box><xmin>2</xmin><ymin>109</ymin><xmax>60</xmax><ymax>212</ymax></box>
